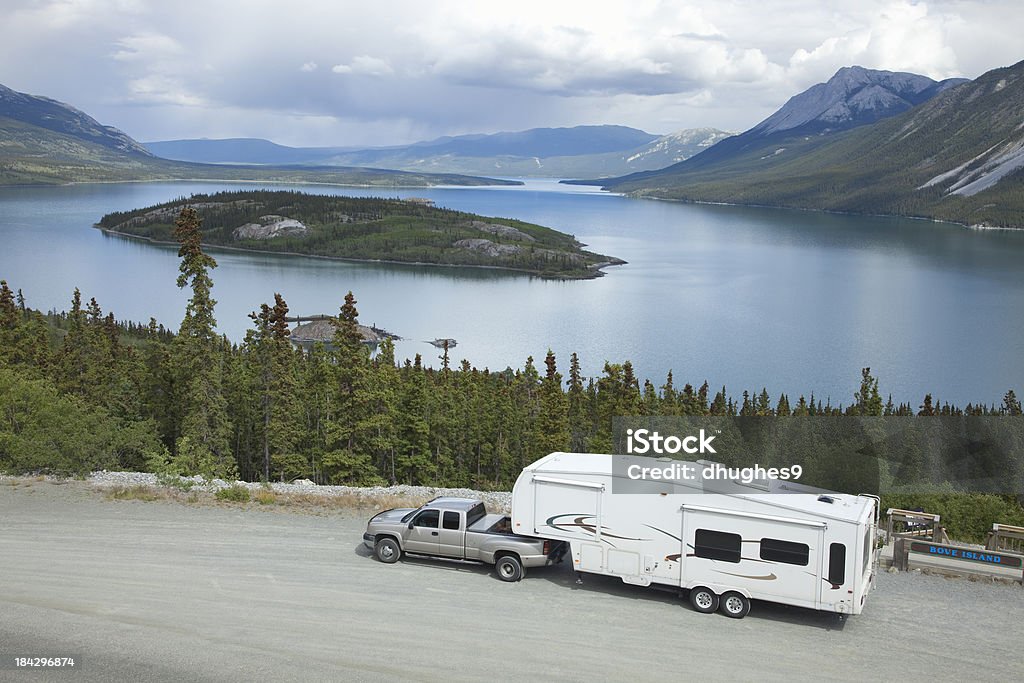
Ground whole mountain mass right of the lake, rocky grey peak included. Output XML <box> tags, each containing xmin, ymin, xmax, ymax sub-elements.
<box><xmin>599</xmin><ymin>61</ymin><xmax>1024</xmax><ymax>227</ymax></box>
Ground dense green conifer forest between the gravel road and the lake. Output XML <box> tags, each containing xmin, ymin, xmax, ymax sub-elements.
<box><xmin>0</xmin><ymin>209</ymin><xmax>1024</xmax><ymax>533</ymax></box>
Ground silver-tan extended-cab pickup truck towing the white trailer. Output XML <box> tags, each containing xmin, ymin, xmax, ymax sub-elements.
<box><xmin>362</xmin><ymin>498</ymin><xmax>566</xmax><ymax>582</ymax></box>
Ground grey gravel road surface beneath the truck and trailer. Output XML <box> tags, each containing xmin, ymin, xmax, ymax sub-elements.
<box><xmin>0</xmin><ymin>481</ymin><xmax>1024</xmax><ymax>681</ymax></box>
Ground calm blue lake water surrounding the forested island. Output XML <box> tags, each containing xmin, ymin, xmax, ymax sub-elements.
<box><xmin>0</xmin><ymin>180</ymin><xmax>1024</xmax><ymax>405</ymax></box>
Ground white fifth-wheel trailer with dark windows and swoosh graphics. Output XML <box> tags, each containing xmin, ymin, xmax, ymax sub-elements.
<box><xmin>512</xmin><ymin>453</ymin><xmax>879</xmax><ymax>618</ymax></box>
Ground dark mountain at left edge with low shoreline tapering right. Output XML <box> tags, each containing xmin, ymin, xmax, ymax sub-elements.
<box><xmin>0</xmin><ymin>85</ymin><xmax>509</xmax><ymax>186</ymax></box>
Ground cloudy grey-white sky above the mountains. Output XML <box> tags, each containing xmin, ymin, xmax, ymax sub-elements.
<box><xmin>0</xmin><ymin>0</ymin><xmax>1024</xmax><ymax>145</ymax></box>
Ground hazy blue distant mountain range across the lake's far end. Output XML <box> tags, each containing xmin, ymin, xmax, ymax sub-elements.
<box><xmin>145</xmin><ymin>126</ymin><xmax>728</xmax><ymax>177</ymax></box>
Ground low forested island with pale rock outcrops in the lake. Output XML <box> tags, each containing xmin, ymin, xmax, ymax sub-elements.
<box><xmin>97</xmin><ymin>190</ymin><xmax>624</xmax><ymax>280</ymax></box>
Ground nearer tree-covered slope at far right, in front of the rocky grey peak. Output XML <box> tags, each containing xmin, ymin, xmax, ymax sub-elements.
<box><xmin>605</xmin><ymin>62</ymin><xmax>1024</xmax><ymax>227</ymax></box>
